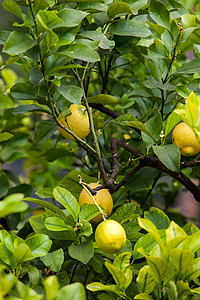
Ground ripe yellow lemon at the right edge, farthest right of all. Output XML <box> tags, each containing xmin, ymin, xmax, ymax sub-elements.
<box><xmin>172</xmin><ymin>122</ymin><xmax>200</xmax><ymax>156</ymax></box>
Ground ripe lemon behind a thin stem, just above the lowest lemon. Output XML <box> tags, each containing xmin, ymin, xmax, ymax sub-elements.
<box><xmin>78</xmin><ymin>182</ymin><xmax>113</xmax><ymax>223</ymax></box>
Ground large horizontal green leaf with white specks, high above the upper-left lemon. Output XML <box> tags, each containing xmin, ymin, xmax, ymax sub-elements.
<box><xmin>57</xmin><ymin>43</ymin><xmax>100</xmax><ymax>63</ymax></box>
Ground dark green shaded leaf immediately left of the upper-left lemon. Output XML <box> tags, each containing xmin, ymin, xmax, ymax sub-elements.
<box><xmin>34</xmin><ymin>120</ymin><xmax>58</xmax><ymax>146</ymax></box>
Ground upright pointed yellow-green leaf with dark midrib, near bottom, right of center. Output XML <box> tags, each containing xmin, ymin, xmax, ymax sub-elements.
<box><xmin>136</xmin><ymin>266</ymin><xmax>156</xmax><ymax>294</ymax></box>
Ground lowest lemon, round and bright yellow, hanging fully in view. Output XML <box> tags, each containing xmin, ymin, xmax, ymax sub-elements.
<box><xmin>95</xmin><ymin>220</ymin><xmax>126</xmax><ymax>254</ymax></box>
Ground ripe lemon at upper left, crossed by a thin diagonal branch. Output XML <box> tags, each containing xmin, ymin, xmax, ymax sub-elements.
<box><xmin>58</xmin><ymin>104</ymin><xmax>90</xmax><ymax>141</ymax></box>
